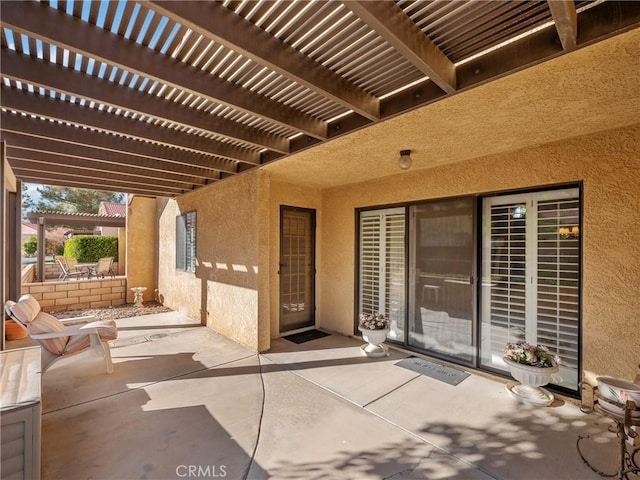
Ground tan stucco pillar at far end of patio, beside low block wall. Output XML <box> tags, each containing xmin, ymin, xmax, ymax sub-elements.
<box><xmin>126</xmin><ymin>197</ymin><xmax>158</xmax><ymax>303</ymax></box>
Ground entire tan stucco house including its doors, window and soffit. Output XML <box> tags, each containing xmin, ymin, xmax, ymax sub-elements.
<box><xmin>128</xmin><ymin>30</ymin><xmax>640</xmax><ymax>402</ymax></box>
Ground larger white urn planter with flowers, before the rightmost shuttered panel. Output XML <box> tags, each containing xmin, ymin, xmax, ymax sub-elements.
<box><xmin>503</xmin><ymin>341</ymin><xmax>560</xmax><ymax>406</ymax></box>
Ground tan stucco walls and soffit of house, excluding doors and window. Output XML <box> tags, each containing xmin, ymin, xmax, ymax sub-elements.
<box><xmin>152</xmin><ymin>29</ymin><xmax>640</xmax><ymax>377</ymax></box>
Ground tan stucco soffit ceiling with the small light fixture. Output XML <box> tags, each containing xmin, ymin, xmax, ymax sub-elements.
<box><xmin>263</xmin><ymin>28</ymin><xmax>640</xmax><ymax>189</ymax></box>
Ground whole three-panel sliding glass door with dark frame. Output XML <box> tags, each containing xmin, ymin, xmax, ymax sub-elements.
<box><xmin>358</xmin><ymin>188</ymin><xmax>581</xmax><ymax>391</ymax></box>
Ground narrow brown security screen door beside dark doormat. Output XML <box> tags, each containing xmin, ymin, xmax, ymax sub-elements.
<box><xmin>279</xmin><ymin>207</ymin><xmax>316</xmax><ymax>333</ymax></box>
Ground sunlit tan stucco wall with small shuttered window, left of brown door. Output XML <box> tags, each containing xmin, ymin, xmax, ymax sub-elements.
<box><xmin>158</xmin><ymin>171</ymin><xmax>269</xmax><ymax>350</ymax></box>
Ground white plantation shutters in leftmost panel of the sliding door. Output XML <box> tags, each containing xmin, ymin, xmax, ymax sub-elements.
<box><xmin>359</xmin><ymin>208</ymin><xmax>406</xmax><ymax>338</ymax></box>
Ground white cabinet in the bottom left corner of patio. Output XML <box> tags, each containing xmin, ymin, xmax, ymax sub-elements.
<box><xmin>0</xmin><ymin>347</ymin><xmax>42</xmax><ymax>480</ymax></box>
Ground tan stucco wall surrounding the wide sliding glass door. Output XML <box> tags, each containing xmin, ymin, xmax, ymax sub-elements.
<box><xmin>318</xmin><ymin>125</ymin><xmax>640</xmax><ymax>378</ymax></box>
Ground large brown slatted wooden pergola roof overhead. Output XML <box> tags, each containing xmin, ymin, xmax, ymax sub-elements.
<box><xmin>0</xmin><ymin>0</ymin><xmax>640</xmax><ymax>197</ymax></box>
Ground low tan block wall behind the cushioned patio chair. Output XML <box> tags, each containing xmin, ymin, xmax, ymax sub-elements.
<box><xmin>22</xmin><ymin>276</ymin><xmax>127</xmax><ymax>312</ymax></box>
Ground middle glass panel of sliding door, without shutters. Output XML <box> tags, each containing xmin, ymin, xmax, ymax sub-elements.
<box><xmin>408</xmin><ymin>198</ymin><xmax>474</xmax><ymax>363</ymax></box>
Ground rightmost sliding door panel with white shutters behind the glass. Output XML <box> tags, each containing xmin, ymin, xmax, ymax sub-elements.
<box><xmin>481</xmin><ymin>188</ymin><xmax>580</xmax><ymax>390</ymax></box>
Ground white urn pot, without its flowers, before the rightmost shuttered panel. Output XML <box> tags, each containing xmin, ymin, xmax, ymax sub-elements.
<box><xmin>503</xmin><ymin>358</ymin><xmax>559</xmax><ymax>406</ymax></box>
